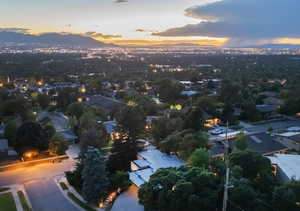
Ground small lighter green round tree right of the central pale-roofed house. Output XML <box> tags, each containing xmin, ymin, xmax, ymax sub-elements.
<box><xmin>190</xmin><ymin>148</ymin><xmax>210</xmax><ymax>168</ymax></box>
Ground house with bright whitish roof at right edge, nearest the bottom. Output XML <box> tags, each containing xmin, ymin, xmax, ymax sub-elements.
<box><xmin>267</xmin><ymin>154</ymin><xmax>300</xmax><ymax>182</ymax></box>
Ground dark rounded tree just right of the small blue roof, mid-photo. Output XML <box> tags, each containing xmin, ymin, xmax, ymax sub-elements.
<box><xmin>117</xmin><ymin>106</ymin><xmax>146</xmax><ymax>140</ymax></box>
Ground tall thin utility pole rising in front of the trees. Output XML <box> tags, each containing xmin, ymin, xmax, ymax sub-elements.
<box><xmin>222</xmin><ymin>121</ymin><xmax>230</xmax><ymax>211</ymax></box>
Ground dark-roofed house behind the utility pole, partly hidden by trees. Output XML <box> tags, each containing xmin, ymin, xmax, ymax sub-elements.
<box><xmin>210</xmin><ymin>133</ymin><xmax>288</xmax><ymax>157</ymax></box>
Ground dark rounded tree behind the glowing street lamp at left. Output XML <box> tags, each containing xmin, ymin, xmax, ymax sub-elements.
<box><xmin>15</xmin><ymin>122</ymin><xmax>49</xmax><ymax>153</ymax></box>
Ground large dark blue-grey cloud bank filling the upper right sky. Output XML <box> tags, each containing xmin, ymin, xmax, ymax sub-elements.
<box><xmin>152</xmin><ymin>0</ymin><xmax>300</xmax><ymax>43</ymax></box>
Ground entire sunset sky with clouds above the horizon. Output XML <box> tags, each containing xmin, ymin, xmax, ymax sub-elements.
<box><xmin>0</xmin><ymin>0</ymin><xmax>300</xmax><ymax>45</ymax></box>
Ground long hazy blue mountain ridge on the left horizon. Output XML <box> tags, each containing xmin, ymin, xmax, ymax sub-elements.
<box><xmin>0</xmin><ymin>31</ymin><xmax>113</xmax><ymax>48</ymax></box>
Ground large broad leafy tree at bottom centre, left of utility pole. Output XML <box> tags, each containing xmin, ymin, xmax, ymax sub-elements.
<box><xmin>138</xmin><ymin>167</ymin><xmax>222</xmax><ymax>211</ymax></box>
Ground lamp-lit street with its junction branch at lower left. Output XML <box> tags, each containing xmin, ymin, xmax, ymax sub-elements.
<box><xmin>0</xmin><ymin>146</ymin><xmax>77</xmax><ymax>211</ymax></box>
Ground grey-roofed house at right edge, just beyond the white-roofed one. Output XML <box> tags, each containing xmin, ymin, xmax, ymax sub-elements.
<box><xmin>275</xmin><ymin>131</ymin><xmax>300</xmax><ymax>151</ymax></box>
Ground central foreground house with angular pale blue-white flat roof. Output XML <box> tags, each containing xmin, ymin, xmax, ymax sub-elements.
<box><xmin>129</xmin><ymin>149</ymin><xmax>185</xmax><ymax>187</ymax></box>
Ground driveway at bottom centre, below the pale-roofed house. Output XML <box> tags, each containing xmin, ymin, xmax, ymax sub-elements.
<box><xmin>111</xmin><ymin>185</ymin><xmax>144</xmax><ymax>211</ymax></box>
